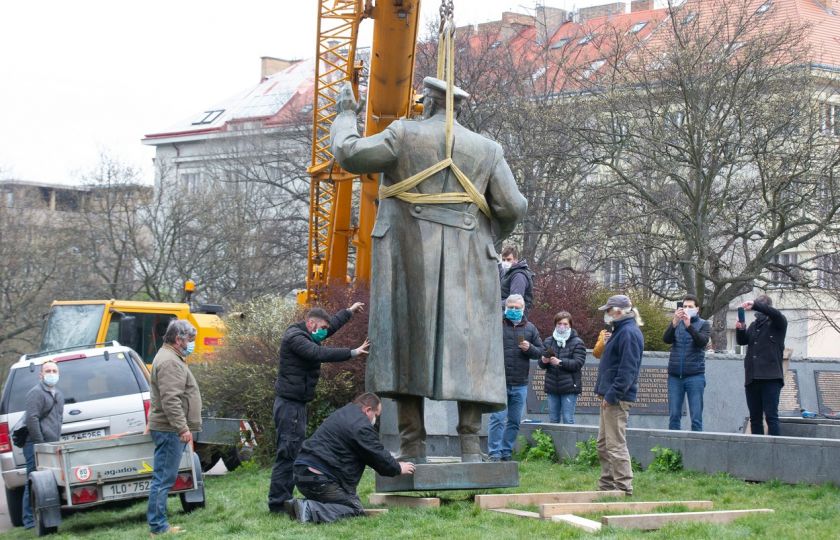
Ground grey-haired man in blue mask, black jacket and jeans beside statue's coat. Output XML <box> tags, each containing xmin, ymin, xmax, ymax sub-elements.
<box><xmin>487</xmin><ymin>294</ymin><xmax>543</xmax><ymax>462</ymax></box>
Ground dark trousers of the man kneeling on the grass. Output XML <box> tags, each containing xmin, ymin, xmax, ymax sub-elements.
<box><xmin>295</xmin><ymin>465</ymin><xmax>365</xmax><ymax>523</ymax></box>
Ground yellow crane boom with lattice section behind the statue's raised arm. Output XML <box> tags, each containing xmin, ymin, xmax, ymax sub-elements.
<box><xmin>299</xmin><ymin>0</ymin><xmax>420</xmax><ymax>302</ymax></box>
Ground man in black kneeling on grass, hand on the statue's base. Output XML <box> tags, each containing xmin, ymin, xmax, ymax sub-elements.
<box><xmin>283</xmin><ymin>392</ymin><xmax>414</xmax><ymax>523</ymax></box>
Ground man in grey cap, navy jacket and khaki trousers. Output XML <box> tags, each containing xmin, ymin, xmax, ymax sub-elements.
<box><xmin>595</xmin><ymin>294</ymin><xmax>645</xmax><ymax>495</ymax></box>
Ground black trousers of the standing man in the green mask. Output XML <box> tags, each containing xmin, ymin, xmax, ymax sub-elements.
<box><xmin>268</xmin><ymin>397</ymin><xmax>306</xmax><ymax>512</ymax></box>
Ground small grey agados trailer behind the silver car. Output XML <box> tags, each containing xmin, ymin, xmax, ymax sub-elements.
<box><xmin>29</xmin><ymin>433</ymin><xmax>204</xmax><ymax>536</ymax></box>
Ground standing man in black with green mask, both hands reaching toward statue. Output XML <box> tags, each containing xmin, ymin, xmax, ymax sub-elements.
<box><xmin>268</xmin><ymin>302</ymin><xmax>369</xmax><ymax>512</ymax></box>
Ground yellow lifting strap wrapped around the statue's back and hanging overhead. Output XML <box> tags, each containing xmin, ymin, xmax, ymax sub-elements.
<box><xmin>379</xmin><ymin>11</ymin><xmax>491</xmax><ymax>217</ymax></box>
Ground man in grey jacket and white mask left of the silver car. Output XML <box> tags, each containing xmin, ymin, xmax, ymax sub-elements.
<box><xmin>23</xmin><ymin>362</ymin><xmax>64</xmax><ymax>529</ymax></box>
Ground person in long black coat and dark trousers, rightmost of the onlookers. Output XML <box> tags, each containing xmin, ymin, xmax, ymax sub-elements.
<box><xmin>735</xmin><ymin>294</ymin><xmax>787</xmax><ymax>435</ymax></box>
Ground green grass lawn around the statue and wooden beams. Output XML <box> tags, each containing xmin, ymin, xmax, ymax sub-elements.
<box><xmin>5</xmin><ymin>462</ymin><xmax>840</xmax><ymax>540</ymax></box>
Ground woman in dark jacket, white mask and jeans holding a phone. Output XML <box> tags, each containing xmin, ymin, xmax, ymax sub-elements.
<box><xmin>539</xmin><ymin>311</ymin><xmax>586</xmax><ymax>424</ymax></box>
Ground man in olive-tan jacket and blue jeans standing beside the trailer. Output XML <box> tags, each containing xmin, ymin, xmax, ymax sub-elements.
<box><xmin>146</xmin><ymin>319</ymin><xmax>201</xmax><ymax>535</ymax></box>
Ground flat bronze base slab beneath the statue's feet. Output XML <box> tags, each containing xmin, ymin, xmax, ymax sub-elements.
<box><xmin>376</xmin><ymin>461</ymin><xmax>519</xmax><ymax>493</ymax></box>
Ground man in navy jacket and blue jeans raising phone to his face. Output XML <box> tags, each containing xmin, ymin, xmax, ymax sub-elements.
<box><xmin>662</xmin><ymin>294</ymin><xmax>712</xmax><ymax>431</ymax></box>
